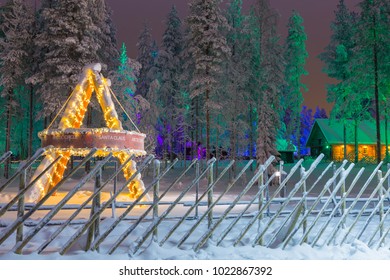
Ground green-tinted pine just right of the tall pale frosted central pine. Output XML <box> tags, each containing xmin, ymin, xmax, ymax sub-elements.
<box><xmin>224</xmin><ymin>0</ymin><xmax>251</xmax><ymax>173</ymax></box>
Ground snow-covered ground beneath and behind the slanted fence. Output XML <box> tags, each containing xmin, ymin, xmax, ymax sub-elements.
<box><xmin>0</xmin><ymin>160</ymin><xmax>390</xmax><ymax>260</ymax></box>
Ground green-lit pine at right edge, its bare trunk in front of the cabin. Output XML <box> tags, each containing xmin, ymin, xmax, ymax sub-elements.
<box><xmin>350</xmin><ymin>0</ymin><xmax>390</xmax><ymax>163</ymax></box>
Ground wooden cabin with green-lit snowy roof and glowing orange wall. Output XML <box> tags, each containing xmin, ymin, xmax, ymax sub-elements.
<box><xmin>306</xmin><ymin>119</ymin><xmax>390</xmax><ymax>162</ymax></box>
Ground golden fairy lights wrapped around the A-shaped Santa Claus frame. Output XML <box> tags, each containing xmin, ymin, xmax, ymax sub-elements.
<box><xmin>27</xmin><ymin>65</ymin><xmax>146</xmax><ymax>200</ymax></box>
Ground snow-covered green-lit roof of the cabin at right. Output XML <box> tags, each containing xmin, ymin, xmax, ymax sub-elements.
<box><xmin>307</xmin><ymin>119</ymin><xmax>390</xmax><ymax>146</ymax></box>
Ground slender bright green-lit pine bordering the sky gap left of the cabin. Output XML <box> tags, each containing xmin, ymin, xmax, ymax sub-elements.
<box><xmin>282</xmin><ymin>11</ymin><xmax>308</xmax><ymax>158</ymax></box>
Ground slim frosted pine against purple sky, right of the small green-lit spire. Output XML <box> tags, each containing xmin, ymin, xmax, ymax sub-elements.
<box><xmin>137</xmin><ymin>23</ymin><xmax>154</xmax><ymax>98</ymax></box>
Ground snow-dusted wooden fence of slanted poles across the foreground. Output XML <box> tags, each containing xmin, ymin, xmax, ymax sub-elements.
<box><xmin>0</xmin><ymin>149</ymin><xmax>390</xmax><ymax>255</ymax></box>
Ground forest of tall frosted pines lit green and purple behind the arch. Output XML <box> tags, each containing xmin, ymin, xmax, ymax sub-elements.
<box><xmin>0</xmin><ymin>0</ymin><xmax>390</xmax><ymax>178</ymax></box>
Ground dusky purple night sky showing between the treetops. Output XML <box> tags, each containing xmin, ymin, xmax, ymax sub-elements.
<box><xmin>106</xmin><ymin>0</ymin><xmax>360</xmax><ymax>115</ymax></box>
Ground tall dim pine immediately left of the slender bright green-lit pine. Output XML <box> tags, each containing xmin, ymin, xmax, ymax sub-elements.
<box><xmin>255</xmin><ymin>0</ymin><xmax>284</xmax><ymax>174</ymax></box>
